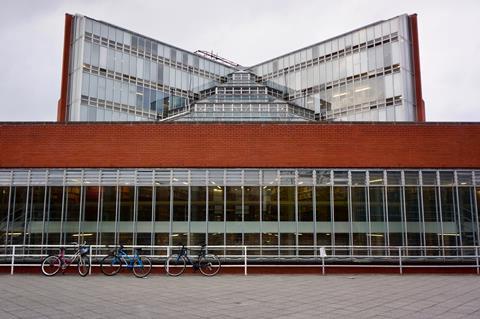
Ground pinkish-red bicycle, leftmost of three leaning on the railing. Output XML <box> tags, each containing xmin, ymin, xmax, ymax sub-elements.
<box><xmin>41</xmin><ymin>242</ymin><xmax>90</xmax><ymax>277</ymax></box>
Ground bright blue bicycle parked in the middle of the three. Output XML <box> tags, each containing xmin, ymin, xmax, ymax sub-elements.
<box><xmin>100</xmin><ymin>245</ymin><xmax>152</xmax><ymax>278</ymax></box>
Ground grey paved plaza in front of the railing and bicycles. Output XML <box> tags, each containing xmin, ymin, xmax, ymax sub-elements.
<box><xmin>0</xmin><ymin>274</ymin><xmax>480</xmax><ymax>319</ymax></box>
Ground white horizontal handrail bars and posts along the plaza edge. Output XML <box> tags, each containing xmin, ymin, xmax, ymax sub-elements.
<box><xmin>0</xmin><ymin>244</ymin><xmax>480</xmax><ymax>276</ymax></box>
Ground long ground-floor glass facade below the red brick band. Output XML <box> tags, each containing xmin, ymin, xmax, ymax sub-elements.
<box><xmin>0</xmin><ymin>169</ymin><xmax>480</xmax><ymax>255</ymax></box>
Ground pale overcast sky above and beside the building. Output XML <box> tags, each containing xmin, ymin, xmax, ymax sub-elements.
<box><xmin>0</xmin><ymin>0</ymin><xmax>480</xmax><ymax>121</ymax></box>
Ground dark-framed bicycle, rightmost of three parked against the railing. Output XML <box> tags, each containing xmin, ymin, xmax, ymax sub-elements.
<box><xmin>165</xmin><ymin>245</ymin><xmax>222</xmax><ymax>277</ymax></box>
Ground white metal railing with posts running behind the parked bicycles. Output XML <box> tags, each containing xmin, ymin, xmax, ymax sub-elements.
<box><xmin>0</xmin><ymin>245</ymin><xmax>480</xmax><ymax>276</ymax></box>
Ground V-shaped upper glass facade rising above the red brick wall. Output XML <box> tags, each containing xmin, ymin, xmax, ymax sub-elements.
<box><xmin>67</xmin><ymin>15</ymin><xmax>417</xmax><ymax>122</ymax></box>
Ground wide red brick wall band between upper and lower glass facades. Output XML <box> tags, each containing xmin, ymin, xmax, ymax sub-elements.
<box><xmin>0</xmin><ymin>123</ymin><xmax>480</xmax><ymax>168</ymax></box>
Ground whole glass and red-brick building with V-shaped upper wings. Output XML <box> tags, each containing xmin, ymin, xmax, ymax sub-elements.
<box><xmin>0</xmin><ymin>15</ymin><xmax>480</xmax><ymax>262</ymax></box>
